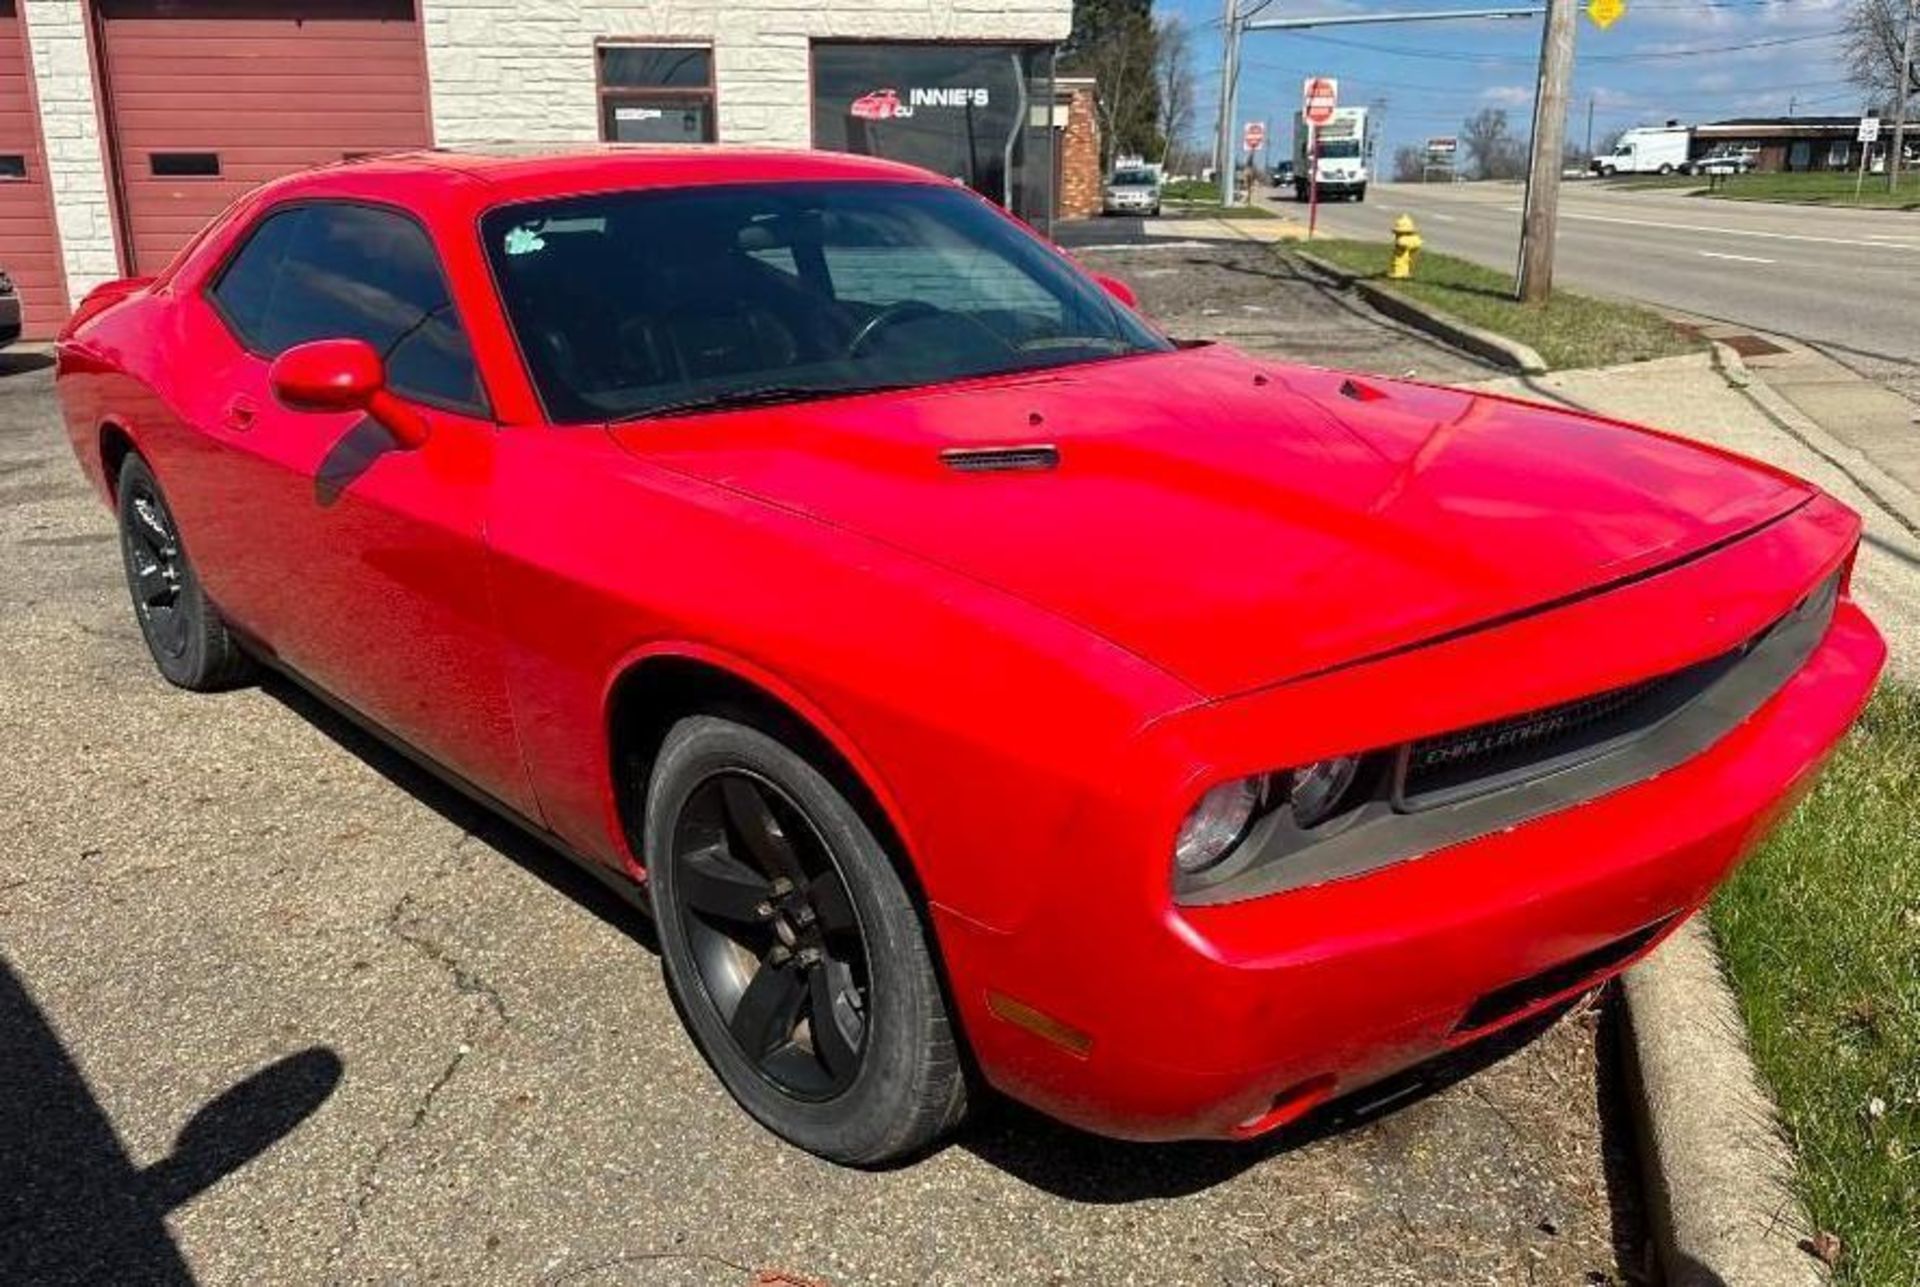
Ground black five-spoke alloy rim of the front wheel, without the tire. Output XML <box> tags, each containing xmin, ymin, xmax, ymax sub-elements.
<box><xmin>670</xmin><ymin>768</ymin><xmax>870</xmax><ymax>1101</ymax></box>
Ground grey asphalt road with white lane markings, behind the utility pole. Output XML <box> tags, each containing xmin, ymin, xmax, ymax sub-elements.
<box><xmin>1305</xmin><ymin>181</ymin><xmax>1920</xmax><ymax>400</ymax></box>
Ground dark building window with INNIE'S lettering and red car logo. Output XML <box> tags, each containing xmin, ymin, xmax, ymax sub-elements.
<box><xmin>814</xmin><ymin>40</ymin><xmax>1066</xmax><ymax>229</ymax></box>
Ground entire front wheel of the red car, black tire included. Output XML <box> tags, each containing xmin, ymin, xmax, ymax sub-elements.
<box><xmin>645</xmin><ymin>715</ymin><xmax>966</xmax><ymax>1166</ymax></box>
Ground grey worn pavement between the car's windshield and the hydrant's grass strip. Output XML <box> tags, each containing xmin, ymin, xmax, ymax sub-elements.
<box><xmin>1073</xmin><ymin>239</ymin><xmax>1498</xmax><ymax>384</ymax></box>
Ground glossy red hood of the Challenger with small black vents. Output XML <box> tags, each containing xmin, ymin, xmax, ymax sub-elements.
<box><xmin>612</xmin><ymin>348</ymin><xmax>1809</xmax><ymax>695</ymax></box>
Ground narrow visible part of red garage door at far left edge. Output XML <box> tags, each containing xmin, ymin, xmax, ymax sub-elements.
<box><xmin>0</xmin><ymin>0</ymin><xmax>67</xmax><ymax>340</ymax></box>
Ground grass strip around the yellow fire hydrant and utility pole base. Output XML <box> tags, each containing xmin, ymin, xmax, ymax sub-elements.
<box><xmin>1308</xmin><ymin>238</ymin><xmax>1701</xmax><ymax>369</ymax></box>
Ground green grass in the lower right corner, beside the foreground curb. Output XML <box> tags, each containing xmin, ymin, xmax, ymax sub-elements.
<box><xmin>1711</xmin><ymin>684</ymin><xmax>1920</xmax><ymax>1287</ymax></box>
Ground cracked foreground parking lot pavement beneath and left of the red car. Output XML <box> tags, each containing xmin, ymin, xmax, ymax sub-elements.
<box><xmin>0</xmin><ymin>345</ymin><xmax>1634</xmax><ymax>1287</ymax></box>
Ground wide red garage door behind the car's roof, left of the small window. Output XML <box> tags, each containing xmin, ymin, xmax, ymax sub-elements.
<box><xmin>100</xmin><ymin>0</ymin><xmax>432</xmax><ymax>273</ymax></box>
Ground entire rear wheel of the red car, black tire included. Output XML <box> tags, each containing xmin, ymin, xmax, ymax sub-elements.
<box><xmin>115</xmin><ymin>453</ymin><xmax>253</xmax><ymax>693</ymax></box>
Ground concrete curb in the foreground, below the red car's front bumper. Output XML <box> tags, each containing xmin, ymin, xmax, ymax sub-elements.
<box><xmin>1622</xmin><ymin>918</ymin><xmax>1830</xmax><ymax>1287</ymax></box>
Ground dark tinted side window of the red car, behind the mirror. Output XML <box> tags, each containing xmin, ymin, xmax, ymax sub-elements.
<box><xmin>211</xmin><ymin>204</ymin><xmax>484</xmax><ymax>413</ymax></box>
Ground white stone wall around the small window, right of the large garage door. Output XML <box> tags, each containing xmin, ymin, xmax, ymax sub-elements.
<box><xmin>420</xmin><ymin>0</ymin><xmax>1073</xmax><ymax>148</ymax></box>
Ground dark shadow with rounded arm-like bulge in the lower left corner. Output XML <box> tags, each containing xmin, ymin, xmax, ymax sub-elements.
<box><xmin>0</xmin><ymin>959</ymin><xmax>342</xmax><ymax>1283</ymax></box>
